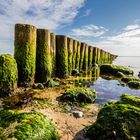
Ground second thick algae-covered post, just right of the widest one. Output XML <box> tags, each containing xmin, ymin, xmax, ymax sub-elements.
<box><xmin>36</xmin><ymin>29</ymin><xmax>52</xmax><ymax>83</ymax></box>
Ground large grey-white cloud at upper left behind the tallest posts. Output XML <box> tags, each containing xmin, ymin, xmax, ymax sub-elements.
<box><xmin>0</xmin><ymin>0</ymin><xmax>85</xmax><ymax>51</ymax></box>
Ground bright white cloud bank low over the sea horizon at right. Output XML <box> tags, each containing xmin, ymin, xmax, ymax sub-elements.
<box><xmin>92</xmin><ymin>25</ymin><xmax>140</xmax><ymax>56</ymax></box>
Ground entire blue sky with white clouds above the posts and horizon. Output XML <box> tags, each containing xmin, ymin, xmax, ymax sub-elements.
<box><xmin>0</xmin><ymin>0</ymin><xmax>140</xmax><ymax>56</ymax></box>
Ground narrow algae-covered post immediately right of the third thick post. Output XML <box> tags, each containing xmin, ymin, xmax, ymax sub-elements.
<box><xmin>67</xmin><ymin>37</ymin><xmax>73</xmax><ymax>75</ymax></box>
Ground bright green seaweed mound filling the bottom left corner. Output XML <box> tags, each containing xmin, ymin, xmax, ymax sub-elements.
<box><xmin>0</xmin><ymin>110</ymin><xmax>59</xmax><ymax>140</ymax></box>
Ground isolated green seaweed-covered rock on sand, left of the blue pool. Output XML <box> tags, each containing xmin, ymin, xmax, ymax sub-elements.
<box><xmin>60</xmin><ymin>87</ymin><xmax>96</xmax><ymax>103</ymax></box>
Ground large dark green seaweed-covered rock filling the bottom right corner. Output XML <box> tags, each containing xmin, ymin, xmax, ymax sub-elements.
<box><xmin>86</xmin><ymin>94</ymin><xmax>140</xmax><ymax>140</ymax></box>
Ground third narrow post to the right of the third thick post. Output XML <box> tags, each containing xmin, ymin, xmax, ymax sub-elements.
<box><xmin>76</xmin><ymin>41</ymin><xmax>81</xmax><ymax>70</ymax></box>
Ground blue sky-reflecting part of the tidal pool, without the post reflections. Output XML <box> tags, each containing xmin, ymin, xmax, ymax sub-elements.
<box><xmin>91</xmin><ymin>77</ymin><xmax>140</xmax><ymax>104</ymax></box>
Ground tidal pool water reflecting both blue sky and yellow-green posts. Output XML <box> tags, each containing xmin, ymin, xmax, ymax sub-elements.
<box><xmin>67</xmin><ymin>68</ymin><xmax>140</xmax><ymax>104</ymax></box>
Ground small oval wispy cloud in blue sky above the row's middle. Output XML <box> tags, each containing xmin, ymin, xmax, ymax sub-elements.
<box><xmin>71</xmin><ymin>24</ymin><xmax>108</xmax><ymax>38</ymax></box>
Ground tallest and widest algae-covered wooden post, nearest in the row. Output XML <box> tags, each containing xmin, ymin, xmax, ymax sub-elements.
<box><xmin>14</xmin><ymin>24</ymin><xmax>36</xmax><ymax>84</ymax></box>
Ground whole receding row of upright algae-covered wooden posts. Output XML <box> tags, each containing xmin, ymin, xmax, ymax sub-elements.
<box><xmin>14</xmin><ymin>24</ymin><xmax>116</xmax><ymax>83</ymax></box>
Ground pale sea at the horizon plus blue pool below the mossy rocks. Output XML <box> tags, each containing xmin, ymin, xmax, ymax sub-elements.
<box><xmin>91</xmin><ymin>56</ymin><xmax>140</xmax><ymax>105</ymax></box>
